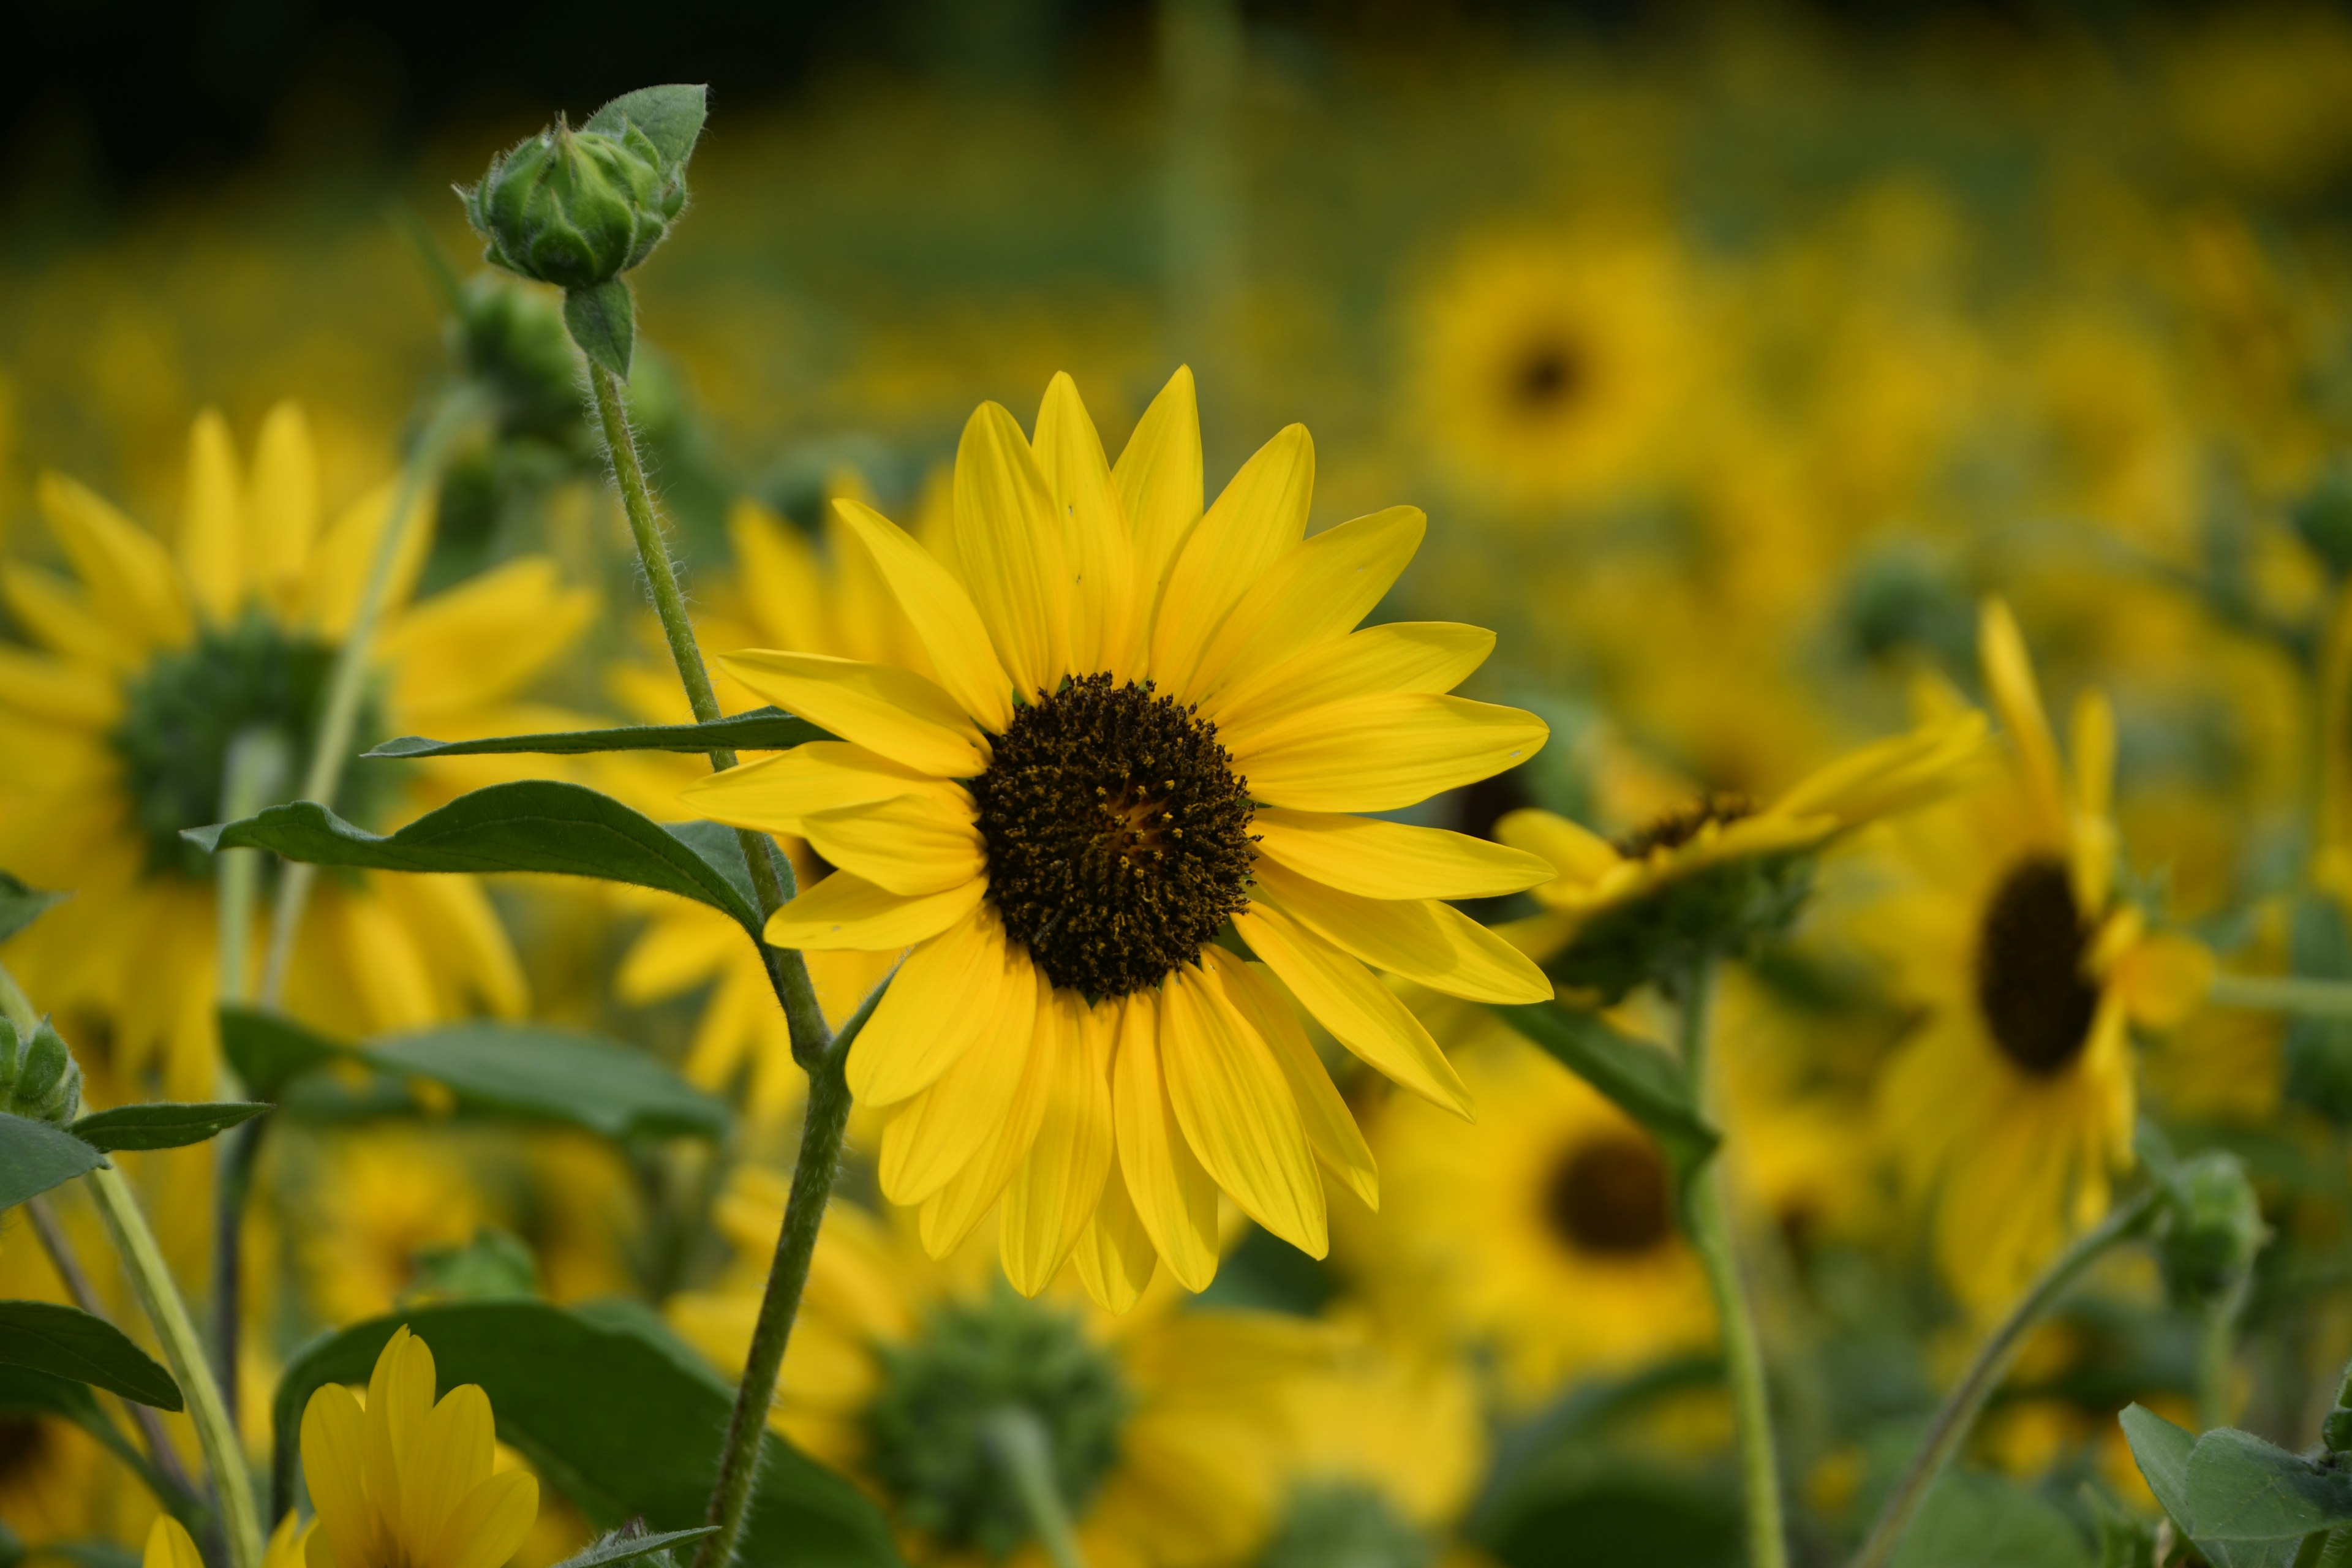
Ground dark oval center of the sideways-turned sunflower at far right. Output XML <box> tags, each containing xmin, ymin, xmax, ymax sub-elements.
<box><xmin>1976</xmin><ymin>856</ymin><xmax>2098</xmax><ymax>1077</ymax></box>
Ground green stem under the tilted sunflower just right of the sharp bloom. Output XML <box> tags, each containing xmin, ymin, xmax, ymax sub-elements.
<box><xmin>1677</xmin><ymin>959</ymin><xmax>1787</xmax><ymax>1568</ymax></box>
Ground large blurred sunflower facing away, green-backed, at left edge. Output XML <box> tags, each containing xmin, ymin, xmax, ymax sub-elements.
<box><xmin>0</xmin><ymin>404</ymin><xmax>590</xmax><ymax>1100</ymax></box>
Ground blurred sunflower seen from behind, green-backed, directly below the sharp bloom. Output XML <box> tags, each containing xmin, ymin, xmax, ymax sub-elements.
<box><xmin>670</xmin><ymin>1166</ymin><xmax>1331</xmax><ymax>1568</ymax></box>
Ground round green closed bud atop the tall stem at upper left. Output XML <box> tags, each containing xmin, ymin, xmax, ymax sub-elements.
<box><xmin>466</xmin><ymin>118</ymin><xmax>687</xmax><ymax>289</ymax></box>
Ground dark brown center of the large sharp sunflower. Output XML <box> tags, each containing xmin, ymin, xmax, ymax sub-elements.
<box><xmin>971</xmin><ymin>675</ymin><xmax>1251</xmax><ymax>997</ymax></box>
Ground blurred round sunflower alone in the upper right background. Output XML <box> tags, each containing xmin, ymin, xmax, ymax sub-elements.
<box><xmin>1411</xmin><ymin>228</ymin><xmax>1703</xmax><ymax>508</ymax></box>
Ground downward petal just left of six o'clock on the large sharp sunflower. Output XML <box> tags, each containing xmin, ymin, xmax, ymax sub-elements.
<box><xmin>997</xmin><ymin>992</ymin><xmax>1117</xmax><ymax>1295</ymax></box>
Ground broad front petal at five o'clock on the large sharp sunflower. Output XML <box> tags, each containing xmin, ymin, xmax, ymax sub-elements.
<box><xmin>1159</xmin><ymin>968</ymin><xmax>1331</xmax><ymax>1257</ymax></box>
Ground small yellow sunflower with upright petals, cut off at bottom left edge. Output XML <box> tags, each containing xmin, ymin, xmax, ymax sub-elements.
<box><xmin>301</xmin><ymin>1326</ymin><xmax>538</xmax><ymax>1568</ymax></box>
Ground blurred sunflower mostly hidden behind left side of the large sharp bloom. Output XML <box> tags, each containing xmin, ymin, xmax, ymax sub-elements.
<box><xmin>607</xmin><ymin>475</ymin><xmax>952</xmax><ymax>1124</ymax></box>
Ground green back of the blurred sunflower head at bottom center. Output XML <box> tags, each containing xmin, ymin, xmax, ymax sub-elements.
<box><xmin>865</xmin><ymin>1286</ymin><xmax>1134</xmax><ymax>1561</ymax></box>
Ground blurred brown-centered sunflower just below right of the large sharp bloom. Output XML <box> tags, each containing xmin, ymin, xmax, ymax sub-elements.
<box><xmin>1348</xmin><ymin>1018</ymin><xmax>1714</xmax><ymax>1408</ymax></box>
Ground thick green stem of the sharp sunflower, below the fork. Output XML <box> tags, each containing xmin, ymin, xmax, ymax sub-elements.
<box><xmin>694</xmin><ymin>980</ymin><xmax>889</xmax><ymax>1568</ymax></box>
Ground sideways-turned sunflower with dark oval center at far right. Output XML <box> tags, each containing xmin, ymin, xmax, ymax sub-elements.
<box><xmin>1858</xmin><ymin>600</ymin><xmax>2211</xmax><ymax>1310</ymax></box>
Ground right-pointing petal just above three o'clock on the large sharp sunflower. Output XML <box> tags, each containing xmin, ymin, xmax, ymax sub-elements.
<box><xmin>1227</xmin><ymin>693</ymin><xmax>1552</xmax><ymax>811</ymax></box>
